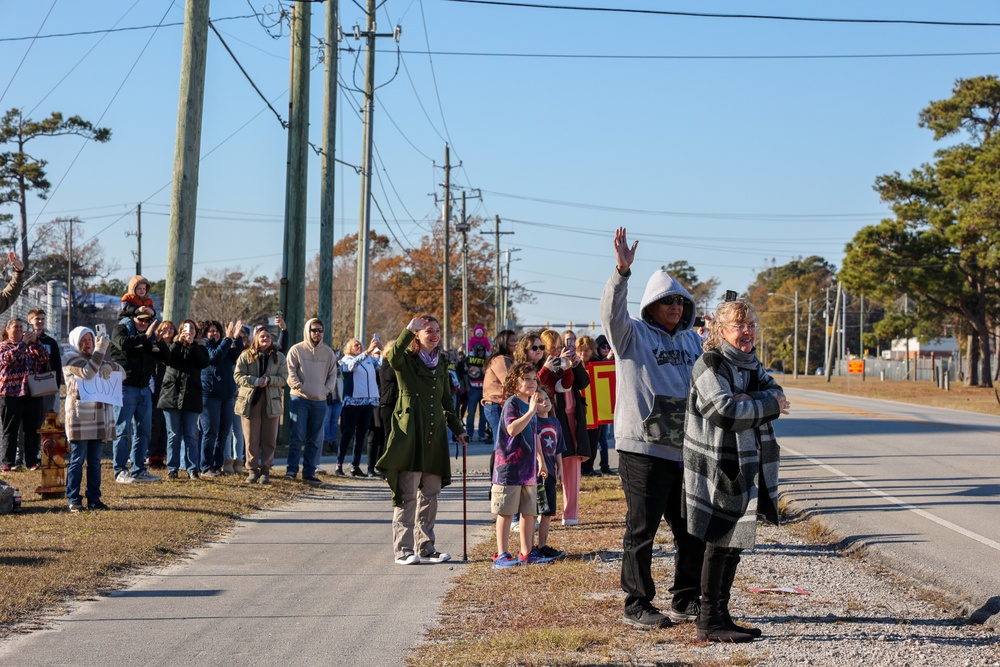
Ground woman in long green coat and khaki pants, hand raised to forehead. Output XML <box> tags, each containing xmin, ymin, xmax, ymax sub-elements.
<box><xmin>375</xmin><ymin>315</ymin><xmax>469</xmax><ymax>565</ymax></box>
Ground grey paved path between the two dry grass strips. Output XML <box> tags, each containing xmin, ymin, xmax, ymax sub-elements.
<box><xmin>0</xmin><ymin>444</ymin><xmax>500</xmax><ymax>667</ymax></box>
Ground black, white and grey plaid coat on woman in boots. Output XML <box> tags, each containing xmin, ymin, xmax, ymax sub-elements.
<box><xmin>684</xmin><ymin>341</ymin><xmax>781</xmax><ymax>549</ymax></box>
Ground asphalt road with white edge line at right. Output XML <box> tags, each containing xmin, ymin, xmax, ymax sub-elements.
<box><xmin>775</xmin><ymin>389</ymin><xmax>1000</xmax><ymax>629</ymax></box>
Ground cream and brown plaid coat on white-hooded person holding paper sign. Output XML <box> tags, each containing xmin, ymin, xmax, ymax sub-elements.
<box><xmin>63</xmin><ymin>327</ymin><xmax>122</xmax><ymax>442</ymax></box>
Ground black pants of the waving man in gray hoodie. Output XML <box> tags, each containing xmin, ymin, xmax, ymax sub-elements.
<box><xmin>618</xmin><ymin>452</ymin><xmax>705</xmax><ymax>611</ymax></box>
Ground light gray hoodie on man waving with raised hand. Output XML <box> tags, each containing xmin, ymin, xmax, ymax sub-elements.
<box><xmin>601</xmin><ymin>269</ymin><xmax>701</xmax><ymax>461</ymax></box>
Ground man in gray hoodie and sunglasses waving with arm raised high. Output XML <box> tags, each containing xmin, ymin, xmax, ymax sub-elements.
<box><xmin>601</xmin><ymin>227</ymin><xmax>705</xmax><ymax>629</ymax></box>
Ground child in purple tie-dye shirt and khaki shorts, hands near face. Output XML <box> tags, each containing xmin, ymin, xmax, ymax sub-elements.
<box><xmin>490</xmin><ymin>363</ymin><xmax>552</xmax><ymax>569</ymax></box>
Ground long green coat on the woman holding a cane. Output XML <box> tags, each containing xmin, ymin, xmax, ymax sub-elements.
<box><xmin>375</xmin><ymin>329</ymin><xmax>465</xmax><ymax>507</ymax></box>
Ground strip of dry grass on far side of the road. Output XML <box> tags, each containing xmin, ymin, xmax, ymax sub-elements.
<box><xmin>776</xmin><ymin>375</ymin><xmax>1000</xmax><ymax>415</ymax></box>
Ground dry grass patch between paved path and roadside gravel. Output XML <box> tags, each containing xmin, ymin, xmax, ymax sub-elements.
<box><xmin>407</xmin><ymin>476</ymin><xmax>736</xmax><ymax>666</ymax></box>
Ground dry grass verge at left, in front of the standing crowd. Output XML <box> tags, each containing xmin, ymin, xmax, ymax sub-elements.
<box><xmin>0</xmin><ymin>461</ymin><xmax>306</xmax><ymax>636</ymax></box>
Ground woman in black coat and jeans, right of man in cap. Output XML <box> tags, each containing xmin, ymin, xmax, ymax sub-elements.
<box><xmin>156</xmin><ymin>320</ymin><xmax>208</xmax><ymax>479</ymax></box>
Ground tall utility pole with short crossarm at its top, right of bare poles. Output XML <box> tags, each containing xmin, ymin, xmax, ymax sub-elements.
<box><xmin>354</xmin><ymin>5</ymin><xmax>401</xmax><ymax>340</ymax></box>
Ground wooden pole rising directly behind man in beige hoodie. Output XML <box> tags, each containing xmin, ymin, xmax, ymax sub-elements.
<box><xmin>319</xmin><ymin>0</ymin><xmax>340</xmax><ymax>346</ymax></box>
